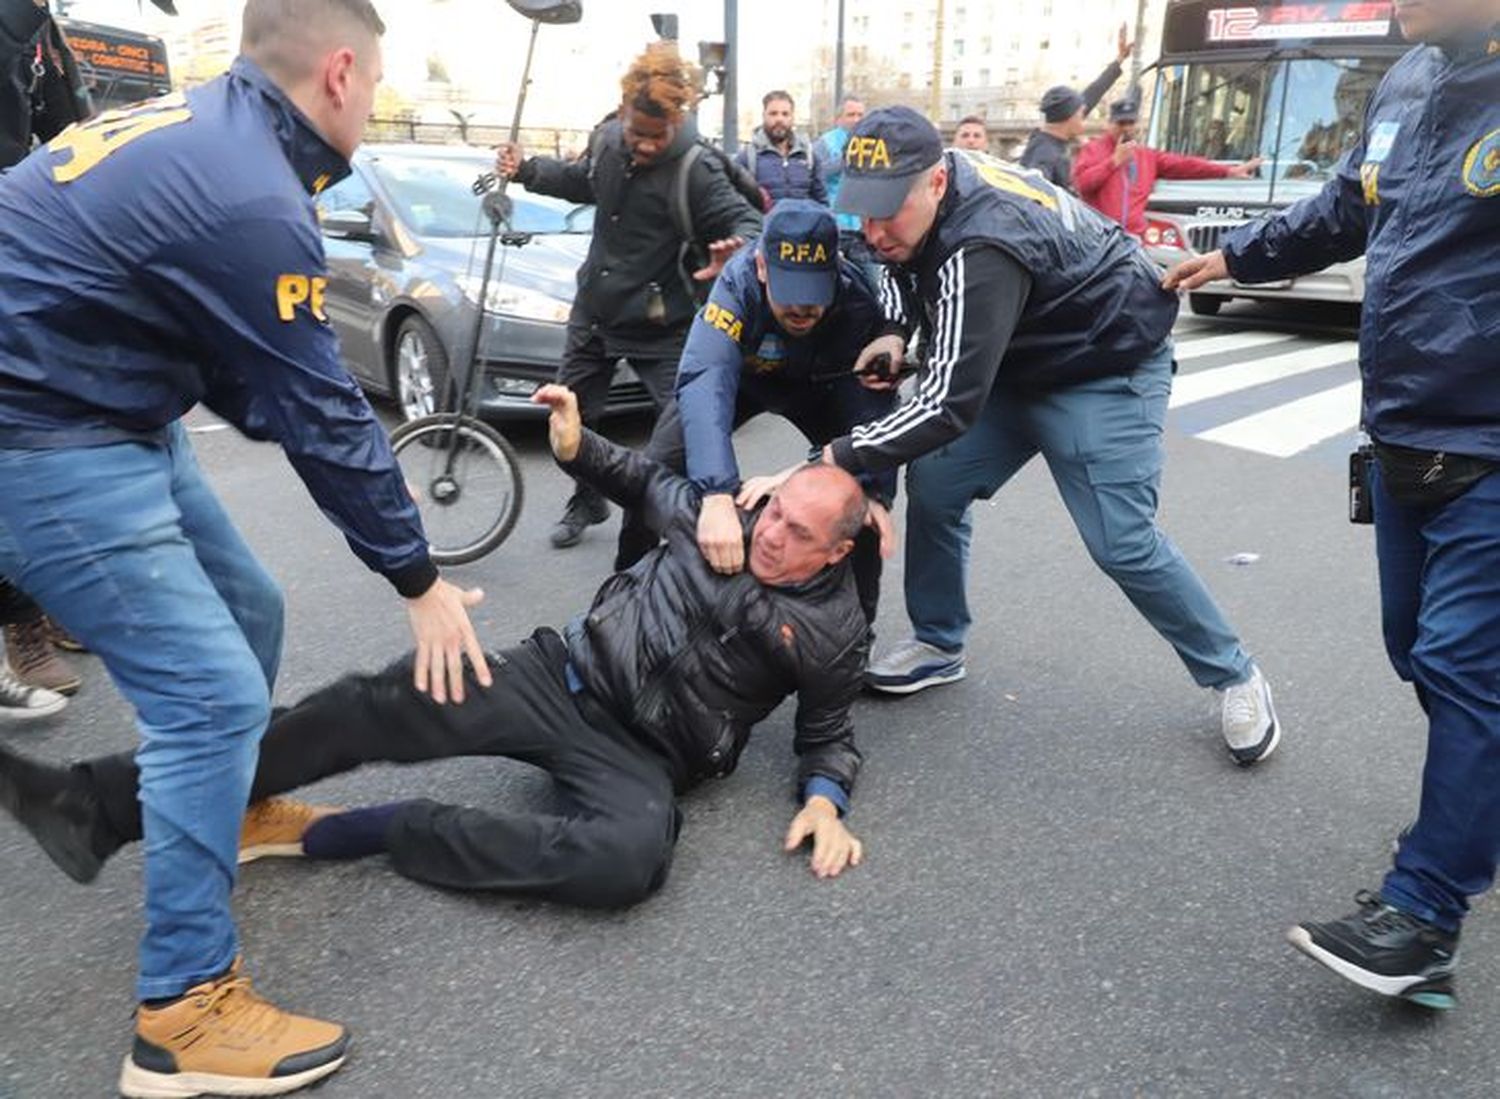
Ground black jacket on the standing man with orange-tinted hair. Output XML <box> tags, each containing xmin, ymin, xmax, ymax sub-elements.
<box><xmin>516</xmin><ymin>118</ymin><xmax>761</xmax><ymax>358</ymax></box>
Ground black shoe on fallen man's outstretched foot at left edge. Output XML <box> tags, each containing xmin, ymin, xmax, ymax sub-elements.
<box><xmin>0</xmin><ymin>737</ymin><xmax>113</xmax><ymax>883</ymax></box>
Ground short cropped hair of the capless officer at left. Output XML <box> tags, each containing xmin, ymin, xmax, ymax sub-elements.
<box><xmin>240</xmin><ymin>0</ymin><xmax>386</xmax><ymax>79</ymax></box>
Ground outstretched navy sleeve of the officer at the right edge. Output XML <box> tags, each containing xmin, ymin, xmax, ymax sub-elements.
<box><xmin>1220</xmin><ymin>141</ymin><xmax>1379</xmax><ymax>282</ymax></box>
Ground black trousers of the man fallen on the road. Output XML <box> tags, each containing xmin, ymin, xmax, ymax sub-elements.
<box><xmin>78</xmin><ymin>630</ymin><xmax>681</xmax><ymax>907</ymax></box>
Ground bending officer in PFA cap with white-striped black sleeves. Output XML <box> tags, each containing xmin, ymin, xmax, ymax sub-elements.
<box><xmin>827</xmin><ymin>106</ymin><xmax>1281</xmax><ymax>763</ymax></box>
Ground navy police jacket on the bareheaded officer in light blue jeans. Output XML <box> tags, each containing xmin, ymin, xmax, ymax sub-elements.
<box><xmin>0</xmin><ymin>57</ymin><xmax>437</xmax><ymax>597</ymax></box>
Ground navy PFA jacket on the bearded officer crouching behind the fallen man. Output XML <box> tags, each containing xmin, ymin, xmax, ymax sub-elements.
<box><xmin>677</xmin><ymin>246</ymin><xmax>896</xmax><ymax>505</ymax></box>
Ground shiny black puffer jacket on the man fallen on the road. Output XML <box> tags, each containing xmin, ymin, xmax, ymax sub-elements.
<box><xmin>563</xmin><ymin>432</ymin><xmax>869</xmax><ymax>790</ymax></box>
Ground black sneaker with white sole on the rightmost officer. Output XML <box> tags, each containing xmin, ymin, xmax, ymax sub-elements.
<box><xmin>1287</xmin><ymin>889</ymin><xmax>1458</xmax><ymax>1011</ymax></box>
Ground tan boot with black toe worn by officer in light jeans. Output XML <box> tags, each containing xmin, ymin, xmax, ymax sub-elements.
<box><xmin>120</xmin><ymin>958</ymin><xmax>350</xmax><ymax>1099</ymax></box>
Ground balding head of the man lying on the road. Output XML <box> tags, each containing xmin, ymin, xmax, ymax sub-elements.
<box><xmin>750</xmin><ymin>465</ymin><xmax>866</xmax><ymax>588</ymax></box>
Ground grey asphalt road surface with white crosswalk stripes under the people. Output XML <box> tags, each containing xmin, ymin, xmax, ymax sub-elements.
<box><xmin>0</xmin><ymin>306</ymin><xmax>1500</xmax><ymax>1099</ymax></box>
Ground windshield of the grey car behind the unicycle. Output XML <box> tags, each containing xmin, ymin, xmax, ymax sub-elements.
<box><xmin>372</xmin><ymin>154</ymin><xmax>594</xmax><ymax>237</ymax></box>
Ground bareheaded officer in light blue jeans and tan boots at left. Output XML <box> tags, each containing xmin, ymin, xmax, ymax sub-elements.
<box><xmin>0</xmin><ymin>0</ymin><xmax>491</xmax><ymax>1096</ymax></box>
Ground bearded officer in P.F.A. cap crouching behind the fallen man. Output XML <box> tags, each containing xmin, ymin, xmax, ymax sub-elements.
<box><xmin>615</xmin><ymin>198</ymin><xmax>896</xmax><ymax>619</ymax></box>
